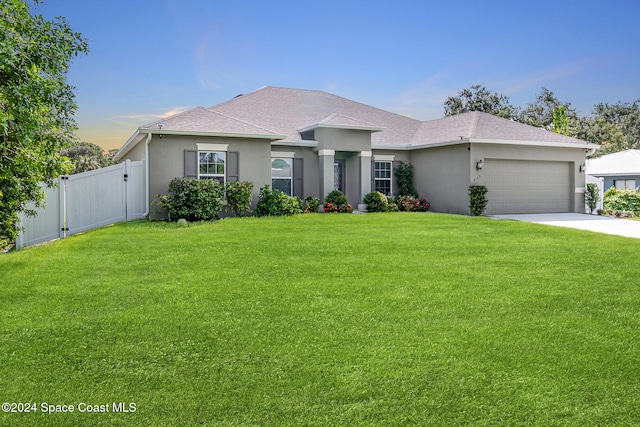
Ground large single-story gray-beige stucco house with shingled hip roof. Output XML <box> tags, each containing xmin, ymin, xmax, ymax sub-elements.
<box><xmin>115</xmin><ymin>87</ymin><xmax>597</xmax><ymax>216</ymax></box>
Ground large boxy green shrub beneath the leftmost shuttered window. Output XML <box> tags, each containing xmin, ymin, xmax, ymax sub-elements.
<box><xmin>169</xmin><ymin>178</ymin><xmax>224</xmax><ymax>221</ymax></box>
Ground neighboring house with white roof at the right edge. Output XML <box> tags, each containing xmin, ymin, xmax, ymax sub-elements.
<box><xmin>587</xmin><ymin>150</ymin><xmax>640</xmax><ymax>190</ymax></box>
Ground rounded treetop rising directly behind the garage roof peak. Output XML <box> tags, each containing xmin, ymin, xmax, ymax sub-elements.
<box><xmin>444</xmin><ymin>84</ymin><xmax>518</xmax><ymax>119</ymax></box>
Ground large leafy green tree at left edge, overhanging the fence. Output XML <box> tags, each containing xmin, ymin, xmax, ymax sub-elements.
<box><xmin>0</xmin><ymin>0</ymin><xmax>88</xmax><ymax>247</ymax></box>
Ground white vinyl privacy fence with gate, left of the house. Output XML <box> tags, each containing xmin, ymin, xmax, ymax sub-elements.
<box><xmin>16</xmin><ymin>160</ymin><xmax>146</xmax><ymax>249</ymax></box>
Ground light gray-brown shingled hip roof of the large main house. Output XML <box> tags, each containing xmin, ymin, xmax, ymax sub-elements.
<box><xmin>116</xmin><ymin>86</ymin><xmax>596</xmax><ymax>162</ymax></box>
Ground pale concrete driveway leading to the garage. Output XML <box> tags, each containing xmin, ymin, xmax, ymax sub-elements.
<box><xmin>491</xmin><ymin>213</ymin><xmax>640</xmax><ymax>239</ymax></box>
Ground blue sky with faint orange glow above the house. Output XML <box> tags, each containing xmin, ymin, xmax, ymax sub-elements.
<box><xmin>32</xmin><ymin>0</ymin><xmax>640</xmax><ymax>150</ymax></box>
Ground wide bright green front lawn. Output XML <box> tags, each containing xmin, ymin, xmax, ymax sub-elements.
<box><xmin>0</xmin><ymin>213</ymin><xmax>640</xmax><ymax>426</ymax></box>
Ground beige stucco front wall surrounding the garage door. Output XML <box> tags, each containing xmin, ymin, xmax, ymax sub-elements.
<box><xmin>469</xmin><ymin>143</ymin><xmax>586</xmax><ymax>212</ymax></box>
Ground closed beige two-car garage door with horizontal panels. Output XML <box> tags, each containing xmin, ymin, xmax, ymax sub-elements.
<box><xmin>482</xmin><ymin>159</ymin><xmax>571</xmax><ymax>215</ymax></box>
